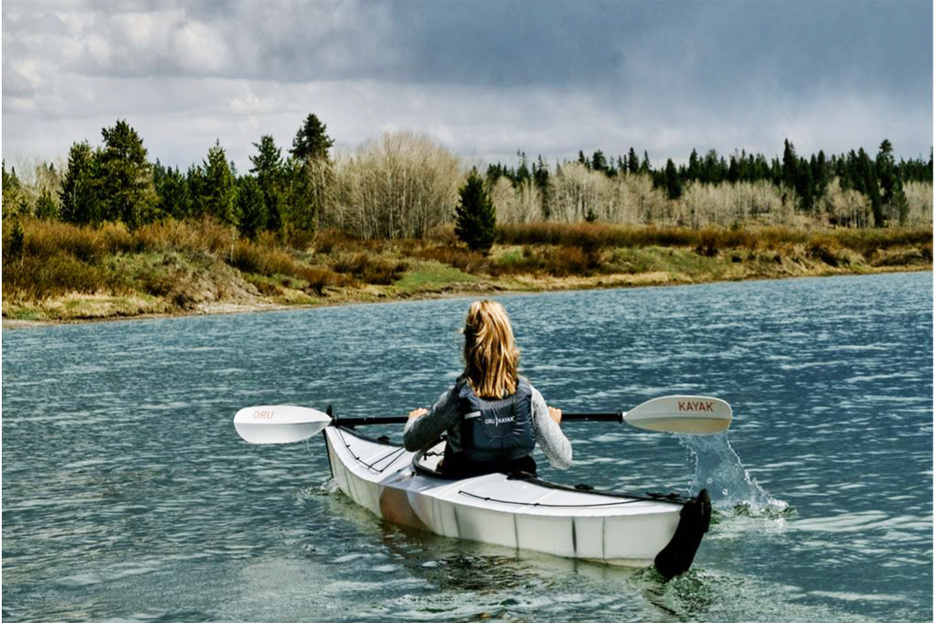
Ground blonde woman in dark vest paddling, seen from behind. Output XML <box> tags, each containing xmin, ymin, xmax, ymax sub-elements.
<box><xmin>403</xmin><ymin>301</ymin><xmax>571</xmax><ymax>478</ymax></box>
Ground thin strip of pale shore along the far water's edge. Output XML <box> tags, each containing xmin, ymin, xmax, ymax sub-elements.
<box><xmin>0</xmin><ymin>266</ymin><xmax>934</xmax><ymax>330</ymax></box>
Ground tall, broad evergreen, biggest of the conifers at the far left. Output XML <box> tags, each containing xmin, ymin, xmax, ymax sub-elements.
<box><xmin>96</xmin><ymin>119</ymin><xmax>157</xmax><ymax>229</ymax></box>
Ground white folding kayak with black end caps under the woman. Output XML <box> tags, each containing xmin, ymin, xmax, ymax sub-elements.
<box><xmin>323</xmin><ymin>420</ymin><xmax>710</xmax><ymax>578</ymax></box>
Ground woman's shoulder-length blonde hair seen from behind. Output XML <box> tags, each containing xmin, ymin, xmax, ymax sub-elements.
<box><xmin>464</xmin><ymin>300</ymin><xmax>519</xmax><ymax>398</ymax></box>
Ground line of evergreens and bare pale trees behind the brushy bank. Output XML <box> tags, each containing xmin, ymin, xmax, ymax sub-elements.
<box><xmin>3</xmin><ymin>114</ymin><xmax>934</xmax><ymax>245</ymax></box>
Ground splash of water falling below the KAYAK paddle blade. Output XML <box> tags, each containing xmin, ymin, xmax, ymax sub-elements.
<box><xmin>678</xmin><ymin>433</ymin><xmax>794</xmax><ymax>518</ymax></box>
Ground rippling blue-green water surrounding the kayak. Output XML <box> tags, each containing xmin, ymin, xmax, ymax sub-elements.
<box><xmin>3</xmin><ymin>273</ymin><xmax>932</xmax><ymax>622</ymax></box>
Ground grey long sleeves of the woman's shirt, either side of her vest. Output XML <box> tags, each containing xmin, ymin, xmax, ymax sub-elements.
<box><xmin>402</xmin><ymin>386</ymin><xmax>571</xmax><ymax>469</ymax></box>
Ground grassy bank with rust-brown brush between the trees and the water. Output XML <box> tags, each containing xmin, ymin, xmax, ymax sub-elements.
<box><xmin>3</xmin><ymin>219</ymin><xmax>932</xmax><ymax>321</ymax></box>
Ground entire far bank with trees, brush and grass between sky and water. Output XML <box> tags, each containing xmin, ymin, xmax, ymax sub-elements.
<box><xmin>3</xmin><ymin>114</ymin><xmax>932</xmax><ymax>320</ymax></box>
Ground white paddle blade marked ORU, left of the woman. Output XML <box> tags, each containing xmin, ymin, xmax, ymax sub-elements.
<box><xmin>234</xmin><ymin>405</ymin><xmax>331</xmax><ymax>444</ymax></box>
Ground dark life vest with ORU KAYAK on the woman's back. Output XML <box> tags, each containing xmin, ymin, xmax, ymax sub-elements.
<box><xmin>458</xmin><ymin>378</ymin><xmax>535</xmax><ymax>463</ymax></box>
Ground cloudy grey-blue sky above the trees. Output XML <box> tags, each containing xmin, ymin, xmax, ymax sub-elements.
<box><xmin>2</xmin><ymin>0</ymin><xmax>934</xmax><ymax>171</ymax></box>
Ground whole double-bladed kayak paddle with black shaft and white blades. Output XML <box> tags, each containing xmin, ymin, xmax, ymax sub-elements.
<box><xmin>234</xmin><ymin>396</ymin><xmax>733</xmax><ymax>444</ymax></box>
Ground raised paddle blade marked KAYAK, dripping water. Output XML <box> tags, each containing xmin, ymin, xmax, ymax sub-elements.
<box><xmin>623</xmin><ymin>396</ymin><xmax>733</xmax><ymax>435</ymax></box>
